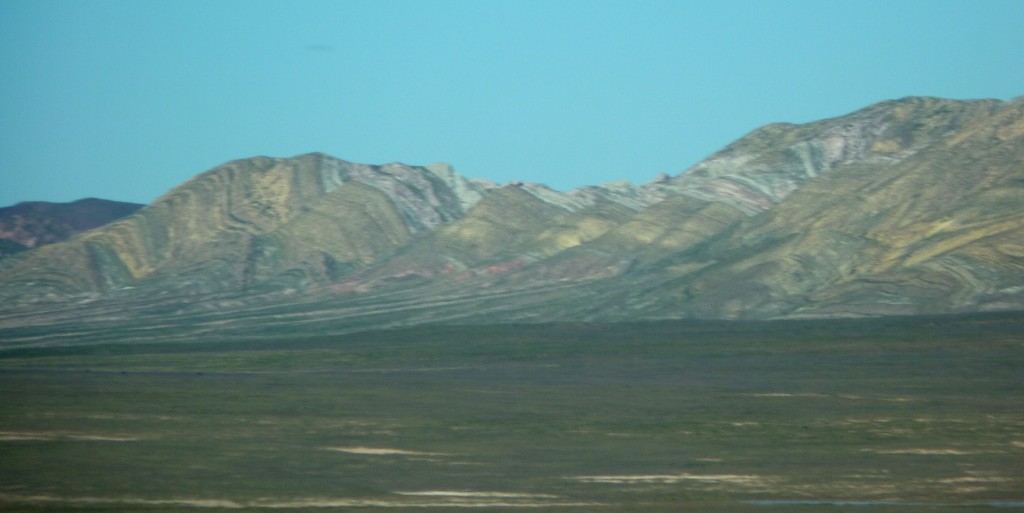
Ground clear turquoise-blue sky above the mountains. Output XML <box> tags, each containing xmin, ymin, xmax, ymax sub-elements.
<box><xmin>0</xmin><ymin>0</ymin><xmax>1024</xmax><ymax>206</ymax></box>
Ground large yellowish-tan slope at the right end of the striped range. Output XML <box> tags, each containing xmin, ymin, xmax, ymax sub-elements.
<box><xmin>593</xmin><ymin>96</ymin><xmax>1024</xmax><ymax>317</ymax></box>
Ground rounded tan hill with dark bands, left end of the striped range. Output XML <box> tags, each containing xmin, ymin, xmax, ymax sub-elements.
<box><xmin>5</xmin><ymin>154</ymin><xmax>493</xmax><ymax>301</ymax></box>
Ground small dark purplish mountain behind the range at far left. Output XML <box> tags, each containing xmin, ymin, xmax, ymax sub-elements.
<box><xmin>0</xmin><ymin>198</ymin><xmax>144</xmax><ymax>258</ymax></box>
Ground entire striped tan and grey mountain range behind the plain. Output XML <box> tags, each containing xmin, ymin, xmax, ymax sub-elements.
<box><xmin>0</xmin><ymin>97</ymin><xmax>1024</xmax><ymax>337</ymax></box>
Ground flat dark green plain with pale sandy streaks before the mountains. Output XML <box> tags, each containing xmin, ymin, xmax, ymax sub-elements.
<box><xmin>0</xmin><ymin>313</ymin><xmax>1024</xmax><ymax>513</ymax></box>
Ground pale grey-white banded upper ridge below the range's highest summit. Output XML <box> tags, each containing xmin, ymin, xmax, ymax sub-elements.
<box><xmin>673</xmin><ymin>96</ymin><xmax>1005</xmax><ymax>215</ymax></box>
